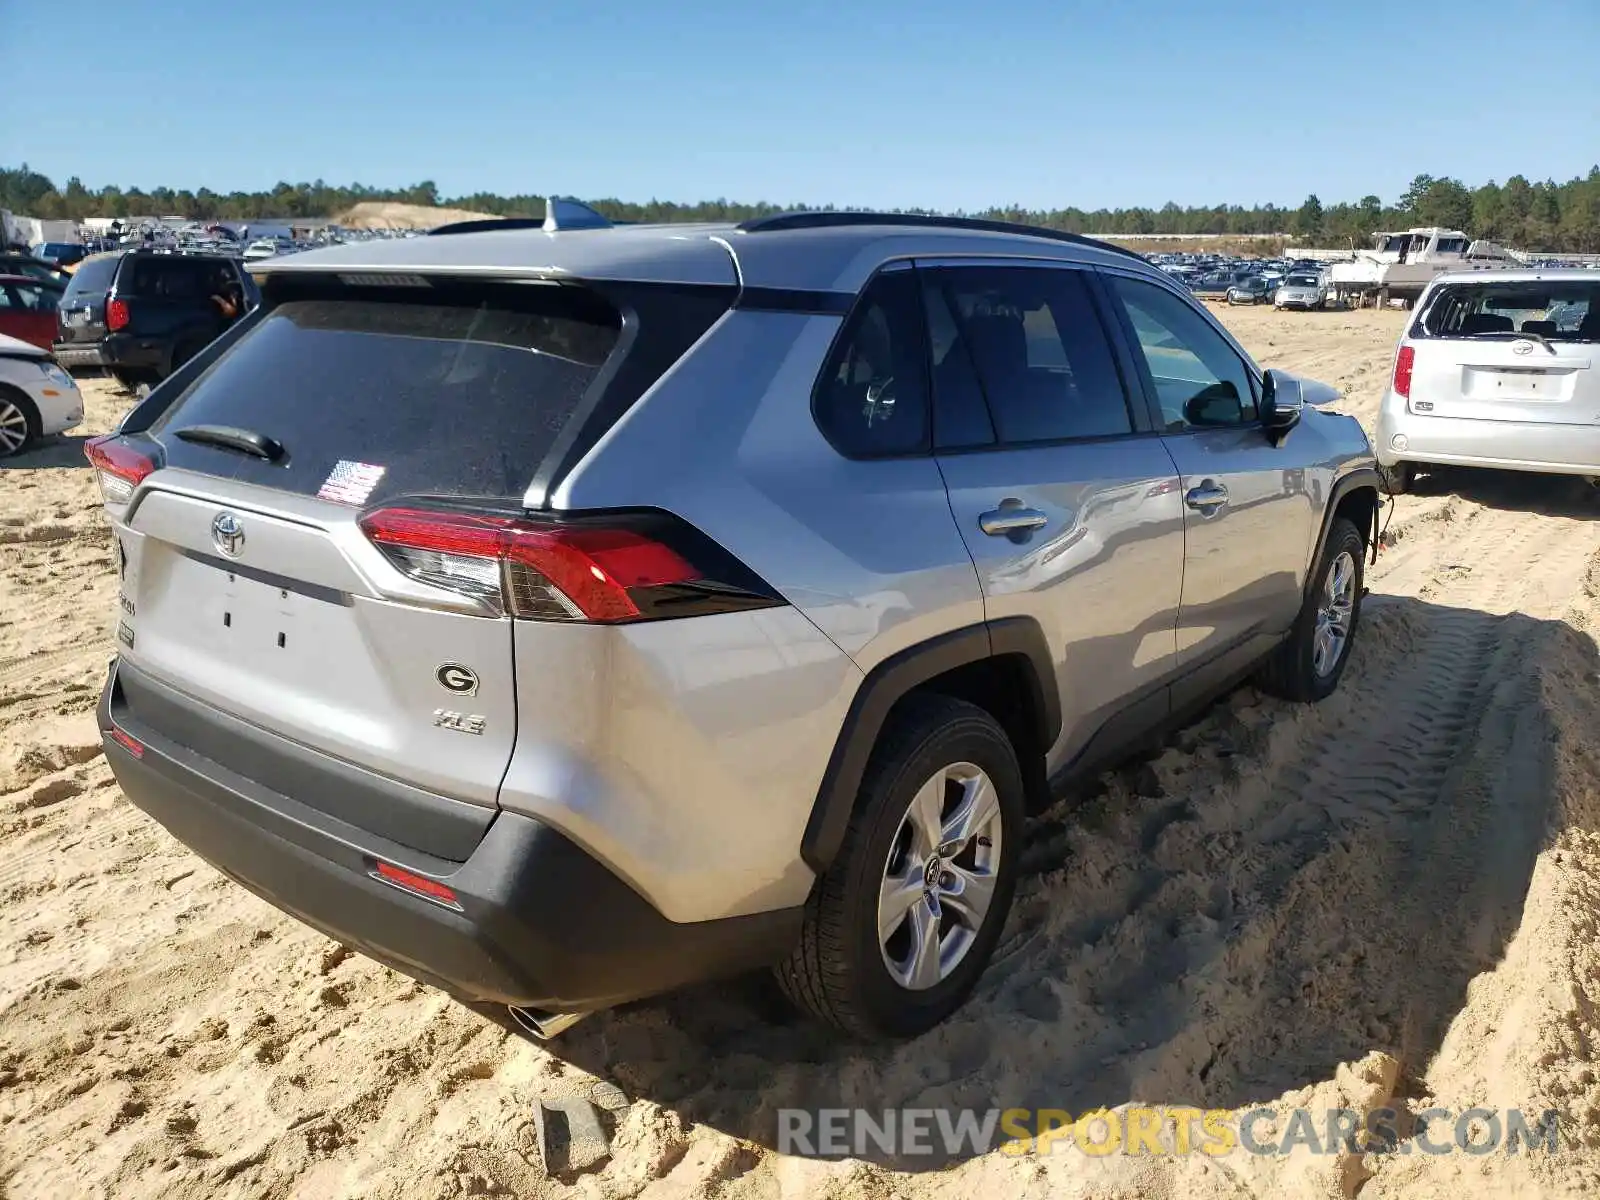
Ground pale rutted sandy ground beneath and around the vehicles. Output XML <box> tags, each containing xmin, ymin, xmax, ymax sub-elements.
<box><xmin>0</xmin><ymin>302</ymin><xmax>1600</xmax><ymax>1200</ymax></box>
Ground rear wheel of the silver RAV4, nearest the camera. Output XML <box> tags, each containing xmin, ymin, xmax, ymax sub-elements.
<box><xmin>776</xmin><ymin>694</ymin><xmax>1024</xmax><ymax>1040</ymax></box>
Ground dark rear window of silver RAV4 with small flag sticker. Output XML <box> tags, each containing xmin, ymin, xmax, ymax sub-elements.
<box><xmin>150</xmin><ymin>285</ymin><xmax>621</xmax><ymax>502</ymax></box>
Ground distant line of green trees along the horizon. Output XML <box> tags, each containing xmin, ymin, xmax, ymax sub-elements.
<box><xmin>0</xmin><ymin>163</ymin><xmax>1600</xmax><ymax>253</ymax></box>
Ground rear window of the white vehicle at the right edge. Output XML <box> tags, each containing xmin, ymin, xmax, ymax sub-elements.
<box><xmin>1411</xmin><ymin>280</ymin><xmax>1600</xmax><ymax>341</ymax></box>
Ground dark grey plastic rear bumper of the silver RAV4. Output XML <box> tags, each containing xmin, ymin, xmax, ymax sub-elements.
<box><xmin>99</xmin><ymin>662</ymin><xmax>802</xmax><ymax>1011</ymax></box>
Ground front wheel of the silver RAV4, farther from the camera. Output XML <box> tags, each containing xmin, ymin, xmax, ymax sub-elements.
<box><xmin>1259</xmin><ymin>517</ymin><xmax>1366</xmax><ymax>704</ymax></box>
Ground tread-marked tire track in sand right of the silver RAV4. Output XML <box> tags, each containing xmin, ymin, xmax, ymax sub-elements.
<box><xmin>1165</xmin><ymin>492</ymin><xmax>1600</xmax><ymax>1101</ymax></box>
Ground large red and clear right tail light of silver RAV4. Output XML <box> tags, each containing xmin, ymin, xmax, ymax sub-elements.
<box><xmin>360</xmin><ymin>507</ymin><xmax>782</xmax><ymax>624</ymax></box>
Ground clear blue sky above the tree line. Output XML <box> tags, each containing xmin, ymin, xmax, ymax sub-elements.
<box><xmin>0</xmin><ymin>0</ymin><xmax>1600</xmax><ymax>210</ymax></box>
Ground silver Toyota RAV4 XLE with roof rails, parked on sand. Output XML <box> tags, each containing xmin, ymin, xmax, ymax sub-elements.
<box><xmin>88</xmin><ymin>206</ymin><xmax>1378</xmax><ymax>1037</ymax></box>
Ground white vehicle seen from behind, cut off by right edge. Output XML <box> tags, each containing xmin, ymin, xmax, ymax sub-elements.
<box><xmin>1378</xmin><ymin>267</ymin><xmax>1600</xmax><ymax>493</ymax></box>
